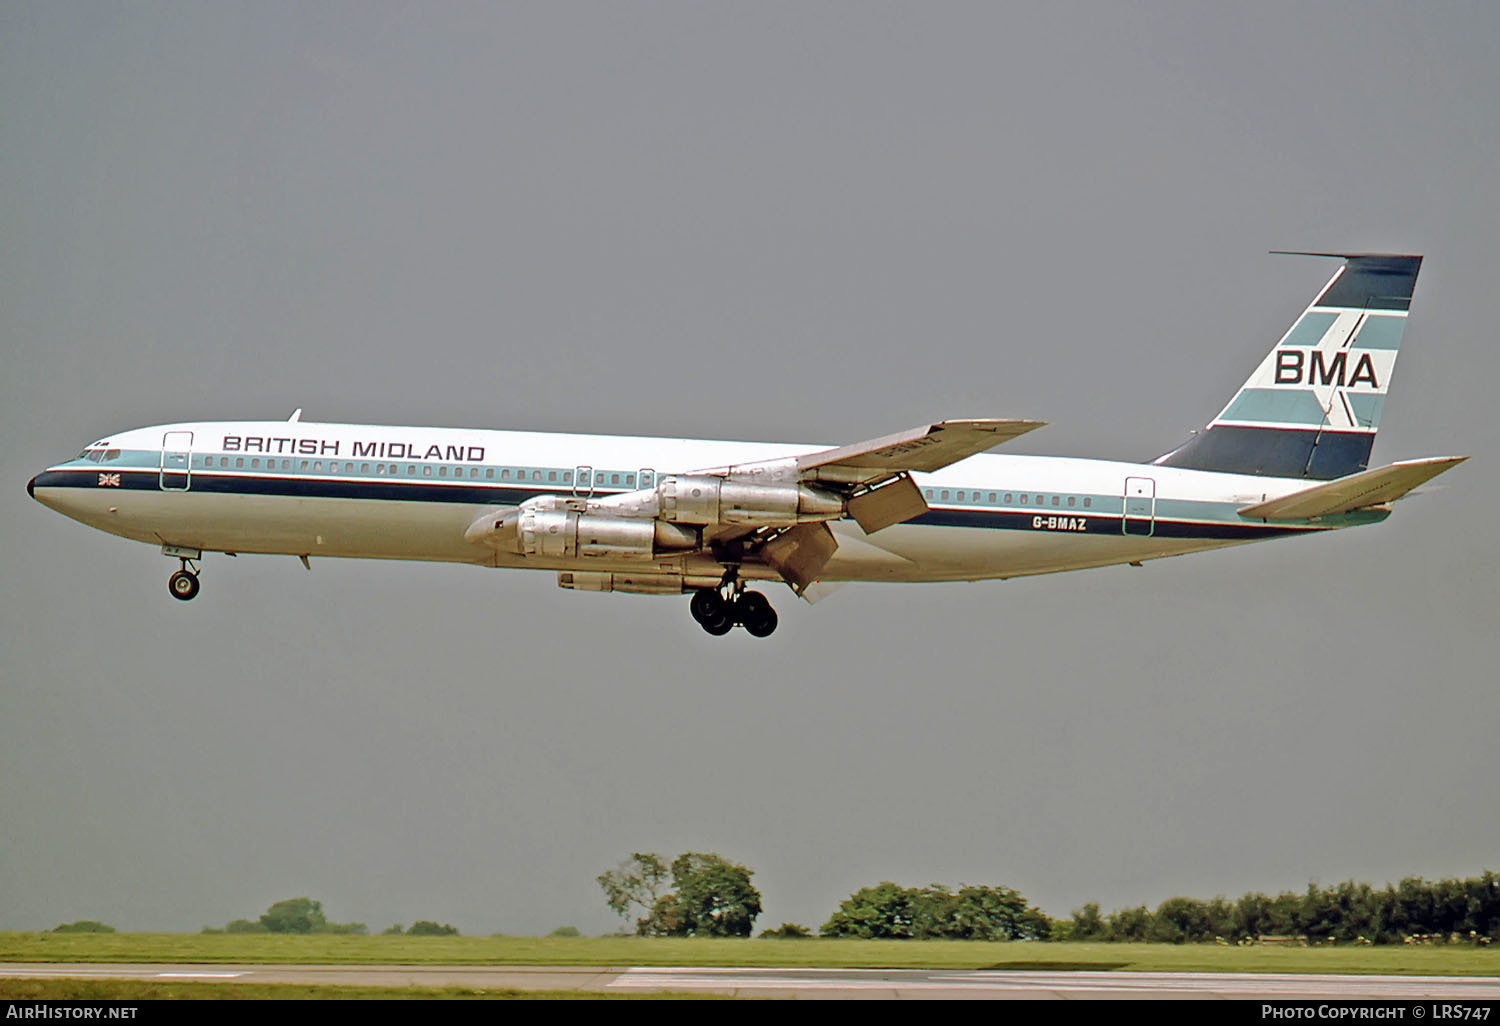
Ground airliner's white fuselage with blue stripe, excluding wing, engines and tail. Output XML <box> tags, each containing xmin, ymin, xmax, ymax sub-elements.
<box><xmin>32</xmin><ymin>422</ymin><xmax>1385</xmax><ymax>581</ymax></box>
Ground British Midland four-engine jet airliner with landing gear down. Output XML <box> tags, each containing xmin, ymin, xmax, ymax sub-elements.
<box><xmin>27</xmin><ymin>254</ymin><xmax>1467</xmax><ymax>638</ymax></box>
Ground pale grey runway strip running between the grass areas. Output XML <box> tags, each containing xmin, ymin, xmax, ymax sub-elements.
<box><xmin>0</xmin><ymin>963</ymin><xmax>1500</xmax><ymax>1002</ymax></box>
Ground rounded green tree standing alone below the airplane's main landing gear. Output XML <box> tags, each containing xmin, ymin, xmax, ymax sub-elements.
<box><xmin>599</xmin><ymin>852</ymin><xmax>761</xmax><ymax>938</ymax></box>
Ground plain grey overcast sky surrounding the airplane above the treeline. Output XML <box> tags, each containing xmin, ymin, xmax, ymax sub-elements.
<box><xmin>0</xmin><ymin>0</ymin><xmax>1500</xmax><ymax>933</ymax></box>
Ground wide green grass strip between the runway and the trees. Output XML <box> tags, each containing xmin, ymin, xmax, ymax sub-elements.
<box><xmin>0</xmin><ymin>933</ymin><xmax>1500</xmax><ymax>977</ymax></box>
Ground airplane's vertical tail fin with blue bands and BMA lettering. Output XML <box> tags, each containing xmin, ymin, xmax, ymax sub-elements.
<box><xmin>1154</xmin><ymin>254</ymin><xmax>1422</xmax><ymax>482</ymax></box>
